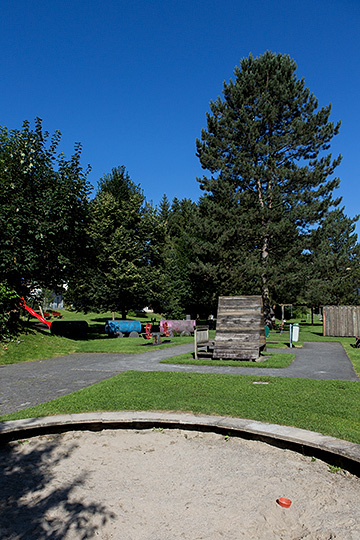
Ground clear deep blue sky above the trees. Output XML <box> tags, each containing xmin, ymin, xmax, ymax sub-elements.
<box><xmin>0</xmin><ymin>0</ymin><xmax>360</xmax><ymax>230</ymax></box>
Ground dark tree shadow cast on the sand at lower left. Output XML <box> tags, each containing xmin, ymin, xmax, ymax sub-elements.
<box><xmin>0</xmin><ymin>435</ymin><xmax>116</xmax><ymax>540</ymax></box>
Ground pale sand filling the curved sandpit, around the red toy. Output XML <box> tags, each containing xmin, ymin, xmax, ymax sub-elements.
<box><xmin>0</xmin><ymin>429</ymin><xmax>360</xmax><ymax>540</ymax></box>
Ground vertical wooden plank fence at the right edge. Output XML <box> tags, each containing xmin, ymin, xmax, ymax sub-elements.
<box><xmin>323</xmin><ymin>306</ymin><xmax>360</xmax><ymax>337</ymax></box>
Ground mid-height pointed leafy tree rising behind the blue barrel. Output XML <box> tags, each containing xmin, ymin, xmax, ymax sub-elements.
<box><xmin>68</xmin><ymin>166</ymin><xmax>160</xmax><ymax>318</ymax></box>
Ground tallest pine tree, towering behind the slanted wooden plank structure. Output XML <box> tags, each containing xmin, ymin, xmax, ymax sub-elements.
<box><xmin>196</xmin><ymin>51</ymin><xmax>341</xmax><ymax>318</ymax></box>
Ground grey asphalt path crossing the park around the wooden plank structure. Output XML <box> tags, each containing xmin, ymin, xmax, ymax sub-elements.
<box><xmin>0</xmin><ymin>342</ymin><xmax>359</xmax><ymax>414</ymax></box>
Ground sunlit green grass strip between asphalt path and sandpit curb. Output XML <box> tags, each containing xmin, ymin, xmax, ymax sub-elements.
<box><xmin>0</xmin><ymin>371</ymin><xmax>360</xmax><ymax>444</ymax></box>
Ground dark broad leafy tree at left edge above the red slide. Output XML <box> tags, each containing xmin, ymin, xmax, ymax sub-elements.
<box><xmin>0</xmin><ymin>118</ymin><xmax>89</xmax><ymax>294</ymax></box>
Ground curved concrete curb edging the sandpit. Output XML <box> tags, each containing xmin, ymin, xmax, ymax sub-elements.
<box><xmin>0</xmin><ymin>411</ymin><xmax>360</xmax><ymax>476</ymax></box>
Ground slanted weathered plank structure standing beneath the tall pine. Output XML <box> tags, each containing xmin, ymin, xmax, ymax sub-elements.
<box><xmin>213</xmin><ymin>296</ymin><xmax>266</xmax><ymax>360</ymax></box>
